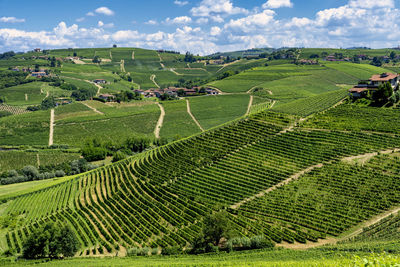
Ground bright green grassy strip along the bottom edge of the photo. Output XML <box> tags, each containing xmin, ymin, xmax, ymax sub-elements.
<box><xmin>1</xmin><ymin>247</ymin><xmax>400</xmax><ymax>267</ymax></box>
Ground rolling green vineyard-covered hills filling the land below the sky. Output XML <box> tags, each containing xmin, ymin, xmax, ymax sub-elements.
<box><xmin>0</xmin><ymin>48</ymin><xmax>400</xmax><ymax>266</ymax></box>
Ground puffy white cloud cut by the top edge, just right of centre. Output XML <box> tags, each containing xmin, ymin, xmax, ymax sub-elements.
<box><xmin>190</xmin><ymin>0</ymin><xmax>248</xmax><ymax>17</ymax></box>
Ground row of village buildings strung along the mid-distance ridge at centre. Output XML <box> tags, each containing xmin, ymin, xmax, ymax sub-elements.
<box><xmin>135</xmin><ymin>87</ymin><xmax>219</xmax><ymax>98</ymax></box>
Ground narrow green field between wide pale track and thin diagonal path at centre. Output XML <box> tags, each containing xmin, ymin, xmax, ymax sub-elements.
<box><xmin>160</xmin><ymin>100</ymin><xmax>200</xmax><ymax>139</ymax></box>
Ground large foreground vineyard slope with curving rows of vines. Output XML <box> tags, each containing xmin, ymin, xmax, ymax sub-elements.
<box><xmin>0</xmin><ymin>103</ymin><xmax>400</xmax><ymax>255</ymax></box>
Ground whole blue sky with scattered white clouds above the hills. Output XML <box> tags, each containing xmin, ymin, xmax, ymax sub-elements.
<box><xmin>0</xmin><ymin>0</ymin><xmax>400</xmax><ymax>55</ymax></box>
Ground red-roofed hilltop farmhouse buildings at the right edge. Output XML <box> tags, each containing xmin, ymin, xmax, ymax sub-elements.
<box><xmin>349</xmin><ymin>72</ymin><xmax>400</xmax><ymax>98</ymax></box>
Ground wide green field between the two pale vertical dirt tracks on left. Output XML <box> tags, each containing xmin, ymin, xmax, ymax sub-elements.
<box><xmin>54</xmin><ymin>101</ymin><xmax>160</xmax><ymax>146</ymax></box>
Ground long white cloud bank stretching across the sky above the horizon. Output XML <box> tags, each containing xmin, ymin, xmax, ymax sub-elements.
<box><xmin>0</xmin><ymin>0</ymin><xmax>400</xmax><ymax>54</ymax></box>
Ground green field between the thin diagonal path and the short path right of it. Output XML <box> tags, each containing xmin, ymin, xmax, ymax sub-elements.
<box><xmin>189</xmin><ymin>94</ymin><xmax>249</xmax><ymax>129</ymax></box>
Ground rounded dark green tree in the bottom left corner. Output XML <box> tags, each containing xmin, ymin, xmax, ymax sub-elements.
<box><xmin>22</xmin><ymin>223</ymin><xmax>79</xmax><ymax>259</ymax></box>
